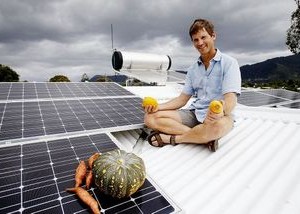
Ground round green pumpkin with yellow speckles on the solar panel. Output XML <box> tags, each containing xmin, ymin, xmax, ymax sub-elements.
<box><xmin>93</xmin><ymin>149</ymin><xmax>146</xmax><ymax>198</ymax></box>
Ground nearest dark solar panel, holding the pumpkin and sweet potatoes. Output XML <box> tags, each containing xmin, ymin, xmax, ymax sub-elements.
<box><xmin>0</xmin><ymin>134</ymin><xmax>177</xmax><ymax>214</ymax></box>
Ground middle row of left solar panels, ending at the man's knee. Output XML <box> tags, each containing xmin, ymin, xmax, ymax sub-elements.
<box><xmin>0</xmin><ymin>97</ymin><xmax>144</xmax><ymax>142</ymax></box>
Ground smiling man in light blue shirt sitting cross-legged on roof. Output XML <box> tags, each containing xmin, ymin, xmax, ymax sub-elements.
<box><xmin>145</xmin><ymin>19</ymin><xmax>241</xmax><ymax>151</ymax></box>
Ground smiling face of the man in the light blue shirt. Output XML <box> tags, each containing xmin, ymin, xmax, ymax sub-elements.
<box><xmin>192</xmin><ymin>28</ymin><xmax>216</xmax><ymax>55</ymax></box>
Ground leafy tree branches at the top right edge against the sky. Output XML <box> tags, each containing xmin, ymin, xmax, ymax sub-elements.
<box><xmin>286</xmin><ymin>0</ymin><xmax>300</xmax><ymax>54</ymax></box>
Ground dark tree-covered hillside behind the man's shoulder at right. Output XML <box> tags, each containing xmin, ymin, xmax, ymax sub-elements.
<box><xmin>240</xmin><ymin>54</ymin><xmax>300</xmax><ymax>82</ymax></box>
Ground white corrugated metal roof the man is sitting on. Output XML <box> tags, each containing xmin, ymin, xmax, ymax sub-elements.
<box><xmin>113</xmin><ymin>86</ymin><xmax>300</xmax><ymax>214</ymax></box>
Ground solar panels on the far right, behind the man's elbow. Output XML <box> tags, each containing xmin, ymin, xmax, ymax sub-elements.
<box><xmin>238</xmin><ymin>89</ymin><xmax>300</xmax><ymax>108</ymax></box>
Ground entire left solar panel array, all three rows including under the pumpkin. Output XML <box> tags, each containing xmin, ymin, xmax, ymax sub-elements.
<box><xmin>0</xmin><ymin>83</ymin><xmax>175</xmax><ymax>214</ymax></box>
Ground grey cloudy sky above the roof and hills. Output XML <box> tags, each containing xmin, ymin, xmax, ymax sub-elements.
<box><xmin>0</xmin><ymin>0</ymin><xmax>296</xmax><ymax>81</ymax></box>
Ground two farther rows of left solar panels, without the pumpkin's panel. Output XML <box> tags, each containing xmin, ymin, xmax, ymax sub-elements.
<box><xmin>0</xmin><ymin>83</ymin><xmax>144</xmax><ymax>143</ymax></box>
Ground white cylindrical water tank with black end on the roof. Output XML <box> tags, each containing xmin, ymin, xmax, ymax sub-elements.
<box><xmin>112</xmin><ymin>51</ymin><xmax>172</xmax><ymax>71</ymax></box>
